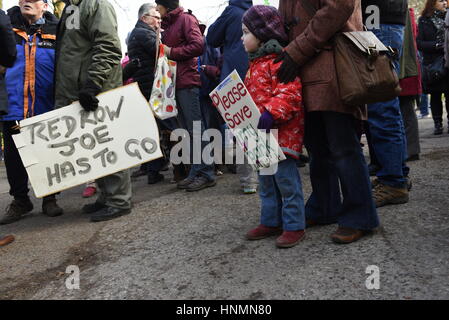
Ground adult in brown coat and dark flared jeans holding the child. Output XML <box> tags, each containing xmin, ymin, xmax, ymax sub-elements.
<box><xmin>278</xmin><ymin>0</ymin><xmax>379</xmax><ymax>243</ymax></box>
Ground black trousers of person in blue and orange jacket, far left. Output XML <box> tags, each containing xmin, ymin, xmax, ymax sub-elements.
<box><xmin>2</xmin><ymin>121</ymin><xmax>30</xmax><ymax>199</ymax></box>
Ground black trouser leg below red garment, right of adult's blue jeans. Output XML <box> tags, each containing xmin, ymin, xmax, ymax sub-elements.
<box><xmin>399</xmin><ymin>96</ymin><xmax>421</xmax><ymax>159</ymax></box>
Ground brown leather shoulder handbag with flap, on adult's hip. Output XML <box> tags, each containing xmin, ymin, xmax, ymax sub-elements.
<box><xmin>300</xmin><ymin>0</ymin><xmax>401</xmax><ymax>106</ymax></box>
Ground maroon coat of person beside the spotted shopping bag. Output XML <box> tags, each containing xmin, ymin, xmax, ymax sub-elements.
<box><xmin>162</xmin><ymin>7</ymin><xmax>204</xmax><ymax>89</ymax></box>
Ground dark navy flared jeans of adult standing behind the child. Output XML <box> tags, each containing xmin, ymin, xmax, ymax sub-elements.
<box><xmin>305</xmin><ymin>112</ymin><xmax>379</xmax><ymax>230</ymax></box>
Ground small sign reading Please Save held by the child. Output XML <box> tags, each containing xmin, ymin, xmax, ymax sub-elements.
<box><xmin>210</xmin><ymin>70</ymin><xmax>286</xmax><ymax>170</ymax></box>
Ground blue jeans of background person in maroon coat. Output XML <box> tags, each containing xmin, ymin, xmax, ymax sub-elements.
<box><xmin>176</xmin><ymin>87</ymin><xmax>215</xmax><ymax>181</ymax></box>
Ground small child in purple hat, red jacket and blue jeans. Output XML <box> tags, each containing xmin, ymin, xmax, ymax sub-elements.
<box><xmin>242</xmin><ymin>5</ymin><xmax>305</xmax><ymax>248</ymax></box>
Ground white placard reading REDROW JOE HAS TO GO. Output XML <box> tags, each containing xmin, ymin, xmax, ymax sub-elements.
<box><xmin>13</xmin><ymin>83</ymin><xmax>162</xmax><ymax>198</ymax></box>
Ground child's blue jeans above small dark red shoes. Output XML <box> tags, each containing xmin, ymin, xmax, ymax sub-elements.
<box><xmin>259</xmin><ymin>158</ymin><xmax>306</xmax><ymax>231</ymax></box>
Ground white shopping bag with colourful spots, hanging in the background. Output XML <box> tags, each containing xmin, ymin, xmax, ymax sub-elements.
<box><xmin>150</xmin><ymin>44</ymin><xmax>178</xmax><ymax>120</ymax></box>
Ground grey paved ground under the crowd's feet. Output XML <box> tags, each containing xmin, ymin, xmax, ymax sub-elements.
<box><xmin>0</xmin><ymin>115</ymin><xmax>449</xmax><ymax>299</ymax></box>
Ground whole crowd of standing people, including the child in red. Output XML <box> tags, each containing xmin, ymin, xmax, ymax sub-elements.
<box><xmin>0</xmin><ymin>0</ymin><xmax>449</xmax><ymax>248</ymax></box>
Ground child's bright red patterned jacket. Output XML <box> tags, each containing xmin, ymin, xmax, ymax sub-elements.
<box><xmin>245</xmin><ymin>54</ymin><xmax>304</xmax><ymax>159</ymax></box>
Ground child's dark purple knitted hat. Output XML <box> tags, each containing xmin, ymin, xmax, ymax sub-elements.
<box><xmin>243</xmin><ymin>5</ymin><xmax>288</xmax><ymax>45</ymax></box>
